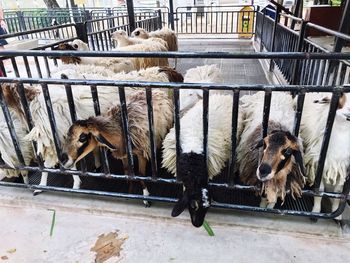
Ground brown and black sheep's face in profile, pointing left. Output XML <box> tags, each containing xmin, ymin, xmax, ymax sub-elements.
<box><xmin>61</xmin><ymin>117</ymin><xmax>124</xmax><ymax>168</ymax></box>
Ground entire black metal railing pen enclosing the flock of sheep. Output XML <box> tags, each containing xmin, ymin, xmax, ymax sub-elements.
<box><xmin>0</xmin><ymin>5</ymin><xmax>350</xmax><ymax>226</ymax></box>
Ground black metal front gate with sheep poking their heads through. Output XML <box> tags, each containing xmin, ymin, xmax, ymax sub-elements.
<box><xmin>0</xmin><ymin>15</ymin><xmax>350</xmax><ymax>224</ymax></box>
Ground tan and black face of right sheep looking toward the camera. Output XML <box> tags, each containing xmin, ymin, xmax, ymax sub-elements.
<box><xmin>256</xmin><ymin>131</ymin><xmax>305</xmax><ymax>182</ymax></box>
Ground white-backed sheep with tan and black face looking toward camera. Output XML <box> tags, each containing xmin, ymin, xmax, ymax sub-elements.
<box><xmin>237</xmin><ymin>92</ymin><xmax>305</xmax><ymax>208</ymax></box>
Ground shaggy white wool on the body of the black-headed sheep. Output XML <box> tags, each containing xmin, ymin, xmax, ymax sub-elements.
<box><xmin>162</xmin><ymin>94</ymin><xmax>242</xmax><ymax>179</ymax></box>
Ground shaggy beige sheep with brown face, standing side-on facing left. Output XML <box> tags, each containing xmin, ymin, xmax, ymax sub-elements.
<box><xmin>62</xmin><ymin>90</ymin><xmax>173</xmax><ymax>207</ymax></box>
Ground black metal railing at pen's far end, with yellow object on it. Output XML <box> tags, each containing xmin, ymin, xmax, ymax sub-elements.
<box><xmin>174</xmin><ymin>5</ymin><xmax>255</xmax><ymax>37</ymax></box>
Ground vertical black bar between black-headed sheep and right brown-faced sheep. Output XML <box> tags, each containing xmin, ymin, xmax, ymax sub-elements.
<box><xmin>227</xmin><ymin>89</ymin><xmax>239</xmax><ymax>186</ymax></box>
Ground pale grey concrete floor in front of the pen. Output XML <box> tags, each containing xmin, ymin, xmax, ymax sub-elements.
<box><xmin>0</xmin><ymin>188</ymin><xmax>350</xmax><ymax>263</ymax></box>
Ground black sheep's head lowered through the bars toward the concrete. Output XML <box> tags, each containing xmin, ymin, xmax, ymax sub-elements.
<box><xmin>171</xmin><ymin>152</ymin><xmax>211</xmax><ymax>227</ymax></box>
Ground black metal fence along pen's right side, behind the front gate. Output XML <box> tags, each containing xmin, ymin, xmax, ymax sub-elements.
<box><xmin>256</xmin><ymin>9</ymin><xmax>350</xmax><ymax>85</ymax></box>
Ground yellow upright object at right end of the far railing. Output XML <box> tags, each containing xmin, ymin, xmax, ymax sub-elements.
<box><xmin>237</xmin><ymin>6</ymin><xmax>254</xmax><ymax>38</ymax></box>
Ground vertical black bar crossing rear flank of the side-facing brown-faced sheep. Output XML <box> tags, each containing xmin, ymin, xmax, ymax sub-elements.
<box><xmin>146</xmin><ymin>87</ymin><xmax>158</xmax><ymax>178</ymax></box>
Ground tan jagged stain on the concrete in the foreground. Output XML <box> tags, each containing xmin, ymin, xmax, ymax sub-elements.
<box><xmin>91</xmin><ymin>230</ymin><xmax>128</xmax><ymax>263</ymax></box>
